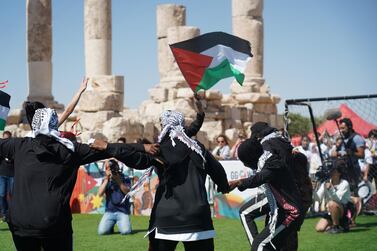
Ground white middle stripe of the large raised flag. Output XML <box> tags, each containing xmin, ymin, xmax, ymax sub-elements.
<box><xmin>200</xmin><ymin>44</ymin><xmax>251</xmax><ymax>73</ymax></box>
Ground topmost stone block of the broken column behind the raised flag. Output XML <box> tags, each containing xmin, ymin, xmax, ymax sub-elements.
<box><xmin>156</xmin><ymin>4</ymin><xmax>186</xmax><ymax>38</ymax></box>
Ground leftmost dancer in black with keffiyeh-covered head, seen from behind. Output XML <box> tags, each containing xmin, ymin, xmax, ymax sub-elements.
<box><xmin>0</xmin><ymin>103</ymin><xmax>159</xmax><ymax>251</ymax></box>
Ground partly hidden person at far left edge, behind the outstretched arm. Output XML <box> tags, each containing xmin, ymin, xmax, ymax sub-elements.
<box><xmin>0</xmin><ymin>131</ymin><xmax>14</xmax><ymax>222</ymax></box>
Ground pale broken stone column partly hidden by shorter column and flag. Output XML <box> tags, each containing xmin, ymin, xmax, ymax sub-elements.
<box><xmin>157</xmin><ymin>4</ymin><xmax>186</xmax><ymax>82</ymax></box>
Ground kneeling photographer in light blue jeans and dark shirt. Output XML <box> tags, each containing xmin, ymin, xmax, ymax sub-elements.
<box><xmin>98</xmin><ymin>160</ymin><xmax>131</xmax><ymax>235</ymax></box>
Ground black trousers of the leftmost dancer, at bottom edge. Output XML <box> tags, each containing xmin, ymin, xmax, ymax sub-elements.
<box><xmin>12</xmin><ymin>233</ymin><xmax>73</xmax><ymax>251</ymax></box>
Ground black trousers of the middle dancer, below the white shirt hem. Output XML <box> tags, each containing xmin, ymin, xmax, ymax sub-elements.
<box><xmin>148</xmin><ymin>232</ymin><xmax>215</xmax><ymax>251</ymax></box>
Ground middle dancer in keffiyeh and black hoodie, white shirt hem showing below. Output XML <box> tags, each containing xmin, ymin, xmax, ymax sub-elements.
<box><xmin>149</xmin><ymin>111</ymin><xmax>229</xmax><ymax>251</ymax></box>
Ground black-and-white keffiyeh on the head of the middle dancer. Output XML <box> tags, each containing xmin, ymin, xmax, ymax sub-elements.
<box><xmin>158</xmin><ymin>110</ymin><xmax>205</xmax><ymax>160</ymax></box>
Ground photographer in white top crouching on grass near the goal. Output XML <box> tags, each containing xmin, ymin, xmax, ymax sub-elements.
<box><xmin>314</xmin><ymin>159</ymin><xmax>351</xmax><ymax>234</ymax></box>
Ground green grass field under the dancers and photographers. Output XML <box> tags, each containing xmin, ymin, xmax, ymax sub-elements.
<box><xmin>0</xmin><ymin>214</ymin><xmax>377</xmax><ymax>251</ymax></box>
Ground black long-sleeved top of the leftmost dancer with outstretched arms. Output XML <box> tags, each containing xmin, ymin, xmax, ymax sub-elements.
<box><xmin>0</xmin><ymin>135</ymin><xmax>152</xmax><ymax>238</ymax></box>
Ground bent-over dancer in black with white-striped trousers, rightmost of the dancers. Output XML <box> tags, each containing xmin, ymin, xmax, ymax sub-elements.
<box><xmin>229</xmin><ymin>138</ymin><xmax>303</xmax><ymax>250</ymax></box>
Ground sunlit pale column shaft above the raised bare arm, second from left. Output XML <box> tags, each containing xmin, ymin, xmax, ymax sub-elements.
<box><xmin>84</xmin><ymin>0</ymin><xmax>111</xmax><ymax>76</ymax></box>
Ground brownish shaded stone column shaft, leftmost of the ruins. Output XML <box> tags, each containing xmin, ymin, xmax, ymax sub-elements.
<box><xmin>26</xmin><ymin>0</ymin><xmax>53</xmax><ymax>104</ymax></box>
